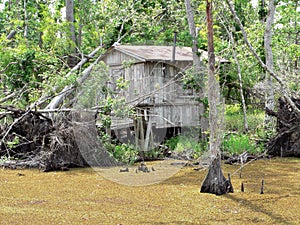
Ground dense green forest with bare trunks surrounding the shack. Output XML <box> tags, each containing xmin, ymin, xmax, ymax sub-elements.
<box><xmin>0</xmin><ymin>0</ymin><xmax>300</xmax><ymax>193</ymax></box>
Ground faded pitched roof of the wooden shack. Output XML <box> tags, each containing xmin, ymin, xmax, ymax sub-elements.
<box><xmin>102</xmin><ymin>45</ymin><xmax>229</xmax><ymax>63</ymax></box>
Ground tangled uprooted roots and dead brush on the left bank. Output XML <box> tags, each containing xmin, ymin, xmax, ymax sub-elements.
<box><xmin>0</xmin><ymin>106</ymin><xmax>115</xmax><ymax>172</ymax></box>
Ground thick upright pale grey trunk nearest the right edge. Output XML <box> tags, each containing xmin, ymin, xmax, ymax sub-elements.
<box><xmin>264</xmin><ymin>0</ymin><xmax>275</xmax><ymax>128</ymax></box>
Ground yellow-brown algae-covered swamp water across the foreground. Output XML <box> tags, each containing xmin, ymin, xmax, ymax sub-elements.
<box><xmin>0</xmin><ymin>158</ymin><xmax>300</xmax><ymax>225</ymax></box>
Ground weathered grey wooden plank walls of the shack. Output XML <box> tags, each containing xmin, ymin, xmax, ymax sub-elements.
<box><xmin>99</xmin><ymin>48</ymin><xmax>199</xmax><ymax>128</ymax></box>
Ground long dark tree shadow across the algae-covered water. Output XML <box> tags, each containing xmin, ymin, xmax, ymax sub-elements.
<box><xmin>225</xmin><ymin>194</ymin><xmax>291</xmax><ymax>224</ymax></box>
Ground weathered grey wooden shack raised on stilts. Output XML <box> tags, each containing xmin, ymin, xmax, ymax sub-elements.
<box><xmin>102</xmin><ymin>45</ymin><xmax>226</xmax><ymax>149</ymax></box>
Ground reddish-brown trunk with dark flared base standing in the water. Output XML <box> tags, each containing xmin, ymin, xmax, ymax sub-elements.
<box><xmin>200</xmin><ymin>0</ymin><xmax>233</xmax><ymax>195</ymax></box>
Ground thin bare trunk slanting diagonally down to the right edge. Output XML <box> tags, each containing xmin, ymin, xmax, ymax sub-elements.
<box><xmin>226</xmin><ymin>0</ymin><xmax>300</xmax><ymax>117</ymax></box>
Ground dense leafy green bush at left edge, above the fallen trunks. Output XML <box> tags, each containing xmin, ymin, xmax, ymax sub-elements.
<box><xmin>0</xmin><ymin>43</ymin><xmax>68</xmax><ymax>104</ymax></box>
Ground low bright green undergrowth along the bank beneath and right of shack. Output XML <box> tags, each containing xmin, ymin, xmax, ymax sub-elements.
<box><xmin>104</xmin><ymin>104</ymin><xmax>273</xmax><ymax>164</ymax></box>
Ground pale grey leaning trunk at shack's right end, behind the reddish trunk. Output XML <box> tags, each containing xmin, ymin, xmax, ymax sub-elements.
<box><xmin>185</xmin><ymin>0</ymin><xmax>208</xmax><ymax>140</ymax></box>
